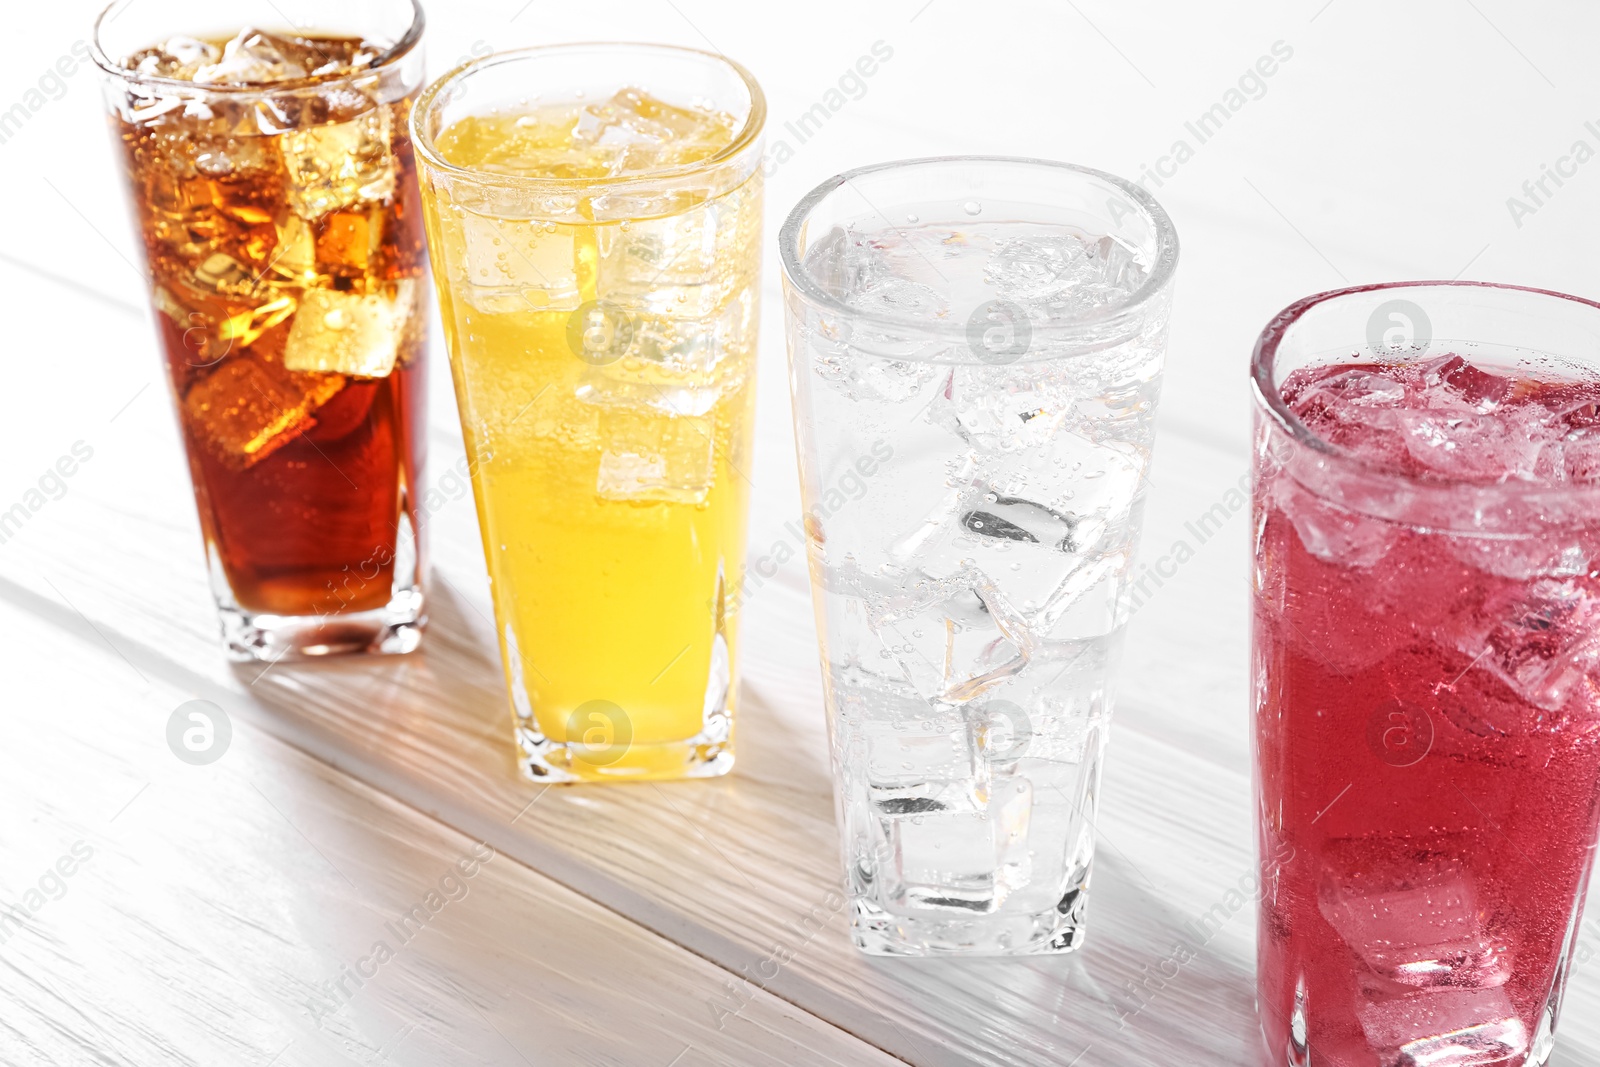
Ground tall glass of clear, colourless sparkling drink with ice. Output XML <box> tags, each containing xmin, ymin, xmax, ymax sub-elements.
<box><xmin>779</xmin><ymin>158</ymin><xmax>1178</xmax><ymax>955</ymax></box>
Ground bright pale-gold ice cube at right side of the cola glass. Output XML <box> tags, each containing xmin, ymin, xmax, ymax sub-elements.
<box><xmin>283</xmin><ymin>278</ymin><xmax>416</xmax><ymax>378</ymax></box>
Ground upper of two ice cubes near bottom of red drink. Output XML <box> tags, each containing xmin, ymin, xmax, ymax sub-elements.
<box><xmin>1318</xmin><ymin>861</ymin><xmax>1510</xmax><ymax>989</ymax></box>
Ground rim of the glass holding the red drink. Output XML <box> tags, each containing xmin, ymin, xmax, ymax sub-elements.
<box><xmin>1250</xmin><ymin>280</ymin><xmax>1600</xmax><ymax>496</ymax></box>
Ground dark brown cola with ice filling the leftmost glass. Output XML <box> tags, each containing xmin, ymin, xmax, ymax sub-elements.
<box><xmin>114</xmin><ymin>30</ymin><xmax>427</xmax><ymax>616</ymax></box>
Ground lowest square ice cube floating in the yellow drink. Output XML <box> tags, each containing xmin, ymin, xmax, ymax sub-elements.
<box><xmin>595</xmin><ymin>406</ymin><xmax>717</xmax><ymax>504</ymax></box>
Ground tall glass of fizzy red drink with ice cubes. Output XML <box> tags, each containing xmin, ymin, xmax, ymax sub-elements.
<box><xmin>1251</xmin><ymin>283</ymin><xmax>1600</xmax><ymax>1067</ymax></box>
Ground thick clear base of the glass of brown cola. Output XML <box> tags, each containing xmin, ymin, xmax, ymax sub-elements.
<box><xmin>218</xmin><ymin>589</ymin><xmax>427</xmax><ymax>664</ymax></box>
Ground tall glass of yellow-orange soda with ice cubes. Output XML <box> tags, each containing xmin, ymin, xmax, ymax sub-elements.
<box><xmin>414</xmin><ymin>45</ymin><xmax>766</xmax><ymax>781</ymax></box>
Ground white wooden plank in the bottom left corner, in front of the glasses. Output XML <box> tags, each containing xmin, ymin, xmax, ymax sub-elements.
<box><xmin>0</xmin><ymin>605</ymin><xmax>894</xmax><ymax>1067</ymax></box>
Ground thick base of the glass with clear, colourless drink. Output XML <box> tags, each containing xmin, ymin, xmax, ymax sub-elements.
<box><xmin>850</xmin><ymin>878</ymin><xmax>1088</xmax><ymax>958</ymax></box>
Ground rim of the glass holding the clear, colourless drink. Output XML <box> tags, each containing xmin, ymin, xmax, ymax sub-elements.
<box><xmin>778</xmin><ymin>155</ymin><xmax>1179</xmax><ymax>339</ymax></box>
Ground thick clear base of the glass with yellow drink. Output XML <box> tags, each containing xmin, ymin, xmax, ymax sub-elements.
<box><xmin>517</xmin><ymin>715</ymin><xmax>733</xmax><ymax>784</ymax></box>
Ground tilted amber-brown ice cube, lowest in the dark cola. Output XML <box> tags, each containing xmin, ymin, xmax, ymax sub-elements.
<box><xmin>184</xmin><ymin>357</ymin><xmax>344</xmax><ymax>469</ymax></box>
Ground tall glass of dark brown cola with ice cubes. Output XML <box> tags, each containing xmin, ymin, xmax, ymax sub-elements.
<box><xmin>94</xmin><ymin>0</ymin><xmax>427</xmax><ymax>661</ymax></box>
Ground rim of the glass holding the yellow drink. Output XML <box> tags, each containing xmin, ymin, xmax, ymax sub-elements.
<box><xmin>411</xmin><ymin>40</ymin><xmax>766</xmax><ymax>192</ymax></box>
